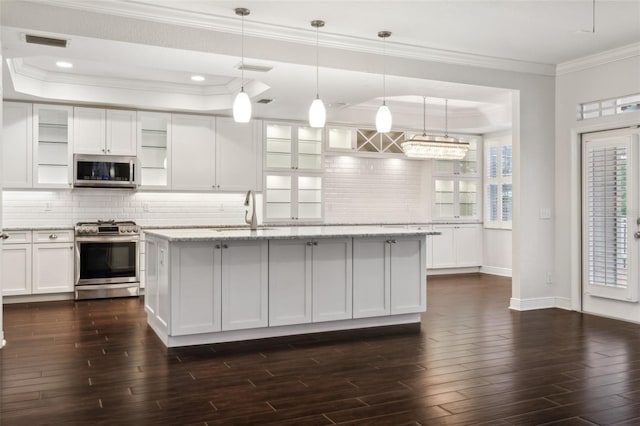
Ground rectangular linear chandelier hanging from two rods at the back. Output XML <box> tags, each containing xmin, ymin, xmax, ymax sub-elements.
<box><xmin>400</xmin><ymin>97</ymin><xmax>469</xmax><ymax>160</ymax></box>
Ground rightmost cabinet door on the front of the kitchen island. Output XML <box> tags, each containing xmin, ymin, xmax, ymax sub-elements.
<box><xmin>390</xmin><ymin>237</ymin><xmax>427</xmax><ymax>315</ymax></box>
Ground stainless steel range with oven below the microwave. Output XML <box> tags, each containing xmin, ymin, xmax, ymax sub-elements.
<box><xmin>75</xmin><ymin>220</ymin><xmax>140</xmax><ymax>299</ymax></box>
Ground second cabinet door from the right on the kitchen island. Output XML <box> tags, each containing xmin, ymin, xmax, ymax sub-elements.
<box><xmin>353</xmin><ymin>238</ymin><xmax>391</xmax><ymax>318</ymax></box>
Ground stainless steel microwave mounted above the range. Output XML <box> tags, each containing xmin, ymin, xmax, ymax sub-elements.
<box><xmin>73</xmin><ymin>154</ymin><xmax>138</xmax><ymax>188</ymax></box>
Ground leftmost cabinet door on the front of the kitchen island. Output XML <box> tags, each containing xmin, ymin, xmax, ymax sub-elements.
<box><xmin>169</xmin><ymin>242</ymin><xmax>222</xmax><ymax>336</ymax></box>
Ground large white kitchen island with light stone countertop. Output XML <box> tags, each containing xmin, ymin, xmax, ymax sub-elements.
<box><xmin>145</xmin><ymin>226</ymin><xmax>433</xmax><ymax>347</ymax></box>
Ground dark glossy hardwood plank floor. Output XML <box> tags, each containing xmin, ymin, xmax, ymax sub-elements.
<box><xmin>0</xmin><ymin>275</ymin><xmax>640</xmax><ymax>426</ymax></box>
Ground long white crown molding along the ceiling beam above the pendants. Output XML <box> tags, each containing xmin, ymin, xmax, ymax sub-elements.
<box><xmin>33</xmin><ymin>0</ymin><xmax>556</xmax><ymax>76</ymax></box>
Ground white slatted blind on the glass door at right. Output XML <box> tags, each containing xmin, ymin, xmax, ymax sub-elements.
<box><xmin>584</xmin><ymin>145</ymin><xmax>629</xmax><ymax>288</ymax></box>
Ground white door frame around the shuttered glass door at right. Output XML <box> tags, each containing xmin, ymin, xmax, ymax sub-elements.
<box><xmin>568</xmin><ymin>113</ymin><xmax>640</xmax><ymax>312</ymax></box>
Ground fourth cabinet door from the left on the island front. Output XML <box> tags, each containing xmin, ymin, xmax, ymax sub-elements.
<box><xmin>312</xmin><ymin>238</ymin><xmax>353</xmax><ymax>322</ymax></box>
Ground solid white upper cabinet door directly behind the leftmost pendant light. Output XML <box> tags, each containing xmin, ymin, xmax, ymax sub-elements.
<box><xmin>215</xmin><ymin>117</ymin><xmax>262</xmax><ymax>191</ymax></box>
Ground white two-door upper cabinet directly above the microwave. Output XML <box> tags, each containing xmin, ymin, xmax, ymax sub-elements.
<box><xmin>73</xmin><ymin>107</ymin><xmax>137</xmax><ymax>155</ymax></box>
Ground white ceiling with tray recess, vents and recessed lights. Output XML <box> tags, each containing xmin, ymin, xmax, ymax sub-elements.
<box><xmin>2</xmin><ymin>0</ymin><xmax>640</xmax><ymax>133</ymax></box>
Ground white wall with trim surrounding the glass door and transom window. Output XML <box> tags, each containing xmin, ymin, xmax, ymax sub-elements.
<box><xmin>553</xmin><ymin>44</ymin><xmax>640</xmax><ymax>309</ymax></box>
